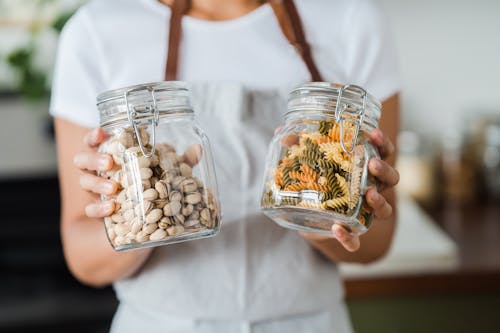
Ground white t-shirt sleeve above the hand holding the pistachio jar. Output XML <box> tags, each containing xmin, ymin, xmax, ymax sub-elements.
<box><xmin>50</xmin><ymin>8</ymin><xmax>105</xmax><ymax>127</ymax></box>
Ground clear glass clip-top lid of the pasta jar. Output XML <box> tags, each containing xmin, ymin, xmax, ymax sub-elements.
<box><xmin>287</xmin><ymin>82</ymin><xmax>381</xmax><ymax>127</ymax></box>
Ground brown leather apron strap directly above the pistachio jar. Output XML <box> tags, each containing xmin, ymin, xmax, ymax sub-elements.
<box><xmin>165</xmin><ymin>0</ymin><xmax>191</xmax><ymax>81</ymax></box>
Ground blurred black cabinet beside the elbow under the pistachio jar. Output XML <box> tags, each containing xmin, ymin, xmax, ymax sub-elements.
<box><xmin>0</xmin><ymin>176</ymin><xmax>117</xmax><ymax>333</ymax></box>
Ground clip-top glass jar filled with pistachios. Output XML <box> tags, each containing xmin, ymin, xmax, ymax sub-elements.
<box><xmin>97</xmin><ymin>81</ymin><xmax>221</xmax><ymax>251</ymax></box>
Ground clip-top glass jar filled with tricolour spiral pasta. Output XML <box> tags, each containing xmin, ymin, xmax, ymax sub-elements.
<box><xmin>261</xmin><ymin>82</ymin><xmax>381</xmax><ymax>235</ymax></box>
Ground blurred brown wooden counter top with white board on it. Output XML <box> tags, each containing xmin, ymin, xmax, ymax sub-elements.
<box><xmin>341</xmin><ymin>196</ymin><xmax>500</xmax><ymax>299</ymax></box>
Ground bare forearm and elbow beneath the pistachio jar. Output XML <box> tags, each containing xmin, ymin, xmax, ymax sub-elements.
<box><xmin>61</xmin><ymin>217</ymin><xmax>151</xmax><ymax>287</ymax></box>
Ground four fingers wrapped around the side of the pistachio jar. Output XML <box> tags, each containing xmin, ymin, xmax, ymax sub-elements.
<box><xmin>73</xmin><ymin>127</ymin><xmax>118</xmax><ymax>218</ymax></box>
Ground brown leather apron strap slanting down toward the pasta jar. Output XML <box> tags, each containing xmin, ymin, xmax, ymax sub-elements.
<box><xmin>269</xmin><ymin>0</ymin><xmax>323</xmax><ymax>81</ymax></box>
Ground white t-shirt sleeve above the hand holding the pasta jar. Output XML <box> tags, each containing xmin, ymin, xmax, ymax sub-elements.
<box><xmin>344</xmin><ymin>0</ymin><xmax>401</xmax><ymax>101</ymax></box>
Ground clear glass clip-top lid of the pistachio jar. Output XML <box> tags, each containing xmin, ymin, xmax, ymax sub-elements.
<box><xmin>97</xmin><ymin>81</ymin><xmax>193</xmax><ymax>126</ymax></box>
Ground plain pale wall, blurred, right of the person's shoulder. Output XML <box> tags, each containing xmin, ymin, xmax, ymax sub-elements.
<box><xmin>378</xmin><ymin>0</ymin><xmax>500</xmax><ymax>135</ymax></box>
